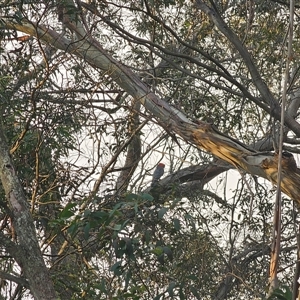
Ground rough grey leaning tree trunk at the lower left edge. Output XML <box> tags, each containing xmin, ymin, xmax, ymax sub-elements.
<box><xmin>0</xmin><ymin>128</ymin><xmax>58</xmax><ymax>300</ymax></box>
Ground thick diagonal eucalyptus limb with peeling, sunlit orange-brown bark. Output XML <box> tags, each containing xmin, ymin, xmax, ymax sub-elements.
<box><xmin>5</xmin><ymin>18</ymin><xmax>300</xmax><ymax>203</ymax></box>
